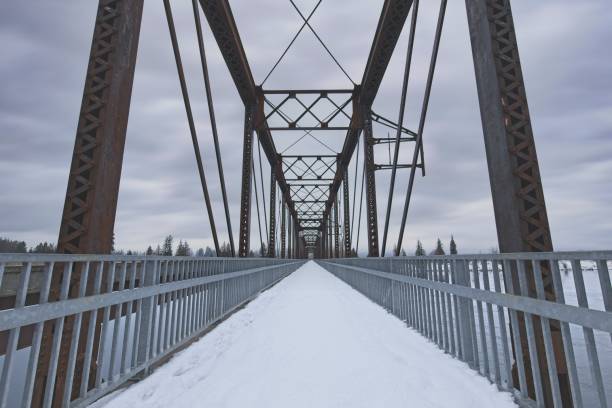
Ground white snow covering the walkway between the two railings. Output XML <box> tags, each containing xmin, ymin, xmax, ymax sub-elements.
<box><xmin>95</xmin><ymin>261</ymin><xmax>516</xmax><ymax>408</ymax></box>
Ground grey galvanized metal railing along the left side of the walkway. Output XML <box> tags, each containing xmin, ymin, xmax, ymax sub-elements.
<box><xmin>0</xmin><ymin>254</ymin><xmax>303</xmax><ymax>407</ymax></box>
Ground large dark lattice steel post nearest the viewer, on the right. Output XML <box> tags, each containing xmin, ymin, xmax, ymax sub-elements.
<box><xmin>466</xmin><ymin>0</ymin><xmax>572</xmax><ymax>406</ymax></box>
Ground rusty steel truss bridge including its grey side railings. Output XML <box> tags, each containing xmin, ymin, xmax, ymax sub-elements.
<box><xmin>0</xmin><ymin>0</ymin><xmax>611</xmax><ymax>407</ymax></box>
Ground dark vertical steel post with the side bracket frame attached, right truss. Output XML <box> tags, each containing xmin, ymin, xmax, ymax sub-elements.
<box><xmin>362</xmin><ymin>109</ymin><xmax>379</xmax><ymax>257</ymax></box>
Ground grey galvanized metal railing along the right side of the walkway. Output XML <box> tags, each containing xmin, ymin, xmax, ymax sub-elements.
<box><xmin>319</xmin><ymin>251</ymin><xmax>612</xmax><ymax>408</ymax></box>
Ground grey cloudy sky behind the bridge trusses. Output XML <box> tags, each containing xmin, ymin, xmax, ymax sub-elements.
<box><xmin>0</xmin><ymin>0</ymin><xmax>612</xmax><ymax>252</ymax></box>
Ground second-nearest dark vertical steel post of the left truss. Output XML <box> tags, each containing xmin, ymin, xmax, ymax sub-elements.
<box><xmin>238</xmin><ymin>106</ymin><xmax>255</xmax><ymax>257</ymax></box>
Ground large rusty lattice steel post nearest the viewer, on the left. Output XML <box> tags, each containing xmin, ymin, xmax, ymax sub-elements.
<box><xmin>32</xmin><ymin>0</ymin><xmax>144</xmax><ymax>406</ymax></box>
